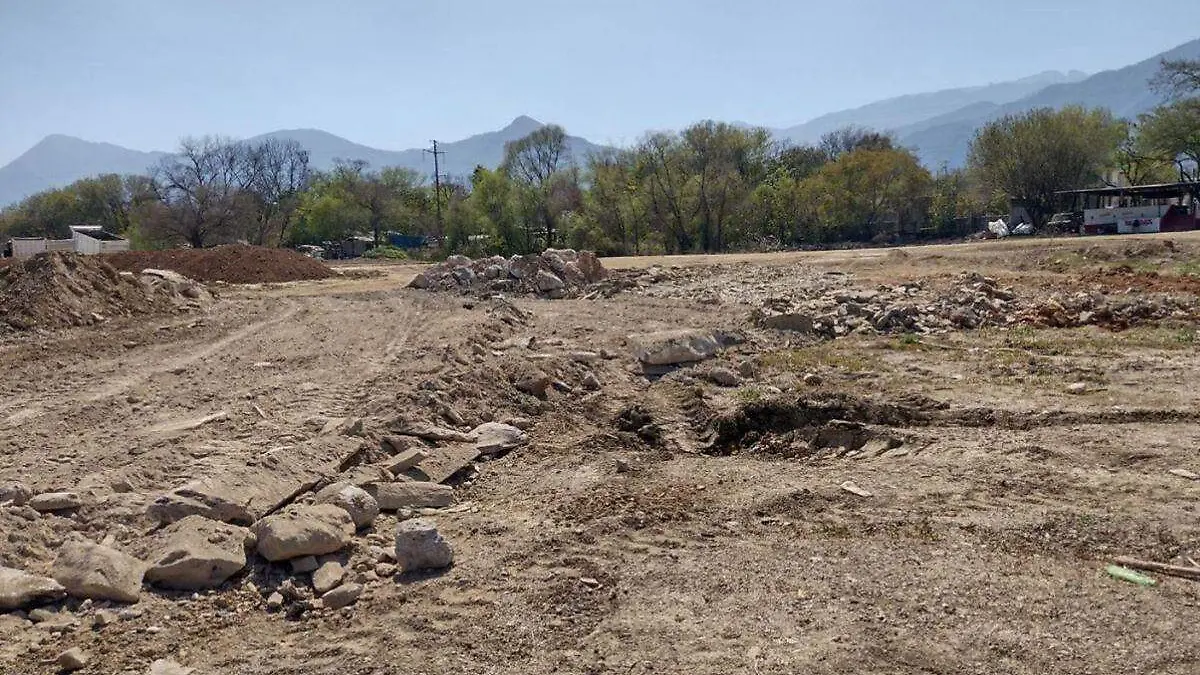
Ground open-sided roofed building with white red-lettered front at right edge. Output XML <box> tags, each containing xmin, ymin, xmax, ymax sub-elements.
<box><xmin>1057</xmin><ymin>183</ymin><xmax>1200</xmax><ymax>234</ymax></box>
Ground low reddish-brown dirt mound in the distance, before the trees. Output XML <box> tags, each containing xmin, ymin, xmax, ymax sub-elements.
<box><xmin>104</xmin><ymin>244</ymin><xmax>334</xmax><ymax>283</ymax></box>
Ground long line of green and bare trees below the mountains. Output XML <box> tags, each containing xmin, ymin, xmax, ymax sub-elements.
<box><xmin>0</xmin><ymin>60</ymin><xmax>1200</xmax><ymax>255</ymax></box>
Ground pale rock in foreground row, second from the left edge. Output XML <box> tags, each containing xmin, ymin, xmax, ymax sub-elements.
<box><xmin>52</xmin><ymin>542</ymin><xmax>145</xmax><ymax>603</ymax></box>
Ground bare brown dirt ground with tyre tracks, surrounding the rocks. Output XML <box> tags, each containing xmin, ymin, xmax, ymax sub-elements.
<box><xmin>0</xmin><ymin>233</ymin><xmax>1200</xmax><ymax>675</ymax></box>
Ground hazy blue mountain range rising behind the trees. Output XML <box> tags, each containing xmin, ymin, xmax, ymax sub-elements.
<box><xmin>0</xmin><ymin>40</ymin><xmax>1200</xmax><ymax>207</ymax></box>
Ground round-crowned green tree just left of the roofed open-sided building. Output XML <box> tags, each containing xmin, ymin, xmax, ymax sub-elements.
<box><xmin>967</xmin><ymin>106</ymin><xmax>1123</xmax><ymax>227</ymax></box>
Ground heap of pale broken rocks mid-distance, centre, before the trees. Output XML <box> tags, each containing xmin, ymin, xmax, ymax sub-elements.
<box><xmin>409</xmin><ymin>249</ymin><xmax>608</xmax><ymax>299</ymax></box>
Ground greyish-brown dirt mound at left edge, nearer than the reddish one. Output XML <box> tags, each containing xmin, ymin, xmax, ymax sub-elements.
<box><xmin>0</xmin><ymin>253</ymin><xmax>211</xmax><ymax>330</ymax></box>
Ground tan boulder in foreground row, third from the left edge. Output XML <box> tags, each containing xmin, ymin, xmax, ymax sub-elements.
<box><xmin>146</xmin><ymin>515</ymin><xmax>250</xmax><ymax>591</ymax></box>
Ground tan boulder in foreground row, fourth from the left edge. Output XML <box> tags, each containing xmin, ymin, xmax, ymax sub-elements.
<box><xmin>253</xmin><ymin>504</ymin><xmax>355</xmax><ymax>562</ymax></box>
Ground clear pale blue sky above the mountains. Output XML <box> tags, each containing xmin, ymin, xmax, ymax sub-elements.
<box><xmin>0</xmin><ymin>0</ymin><xmax>1200</xmax><ymax>166</ymax></box>
